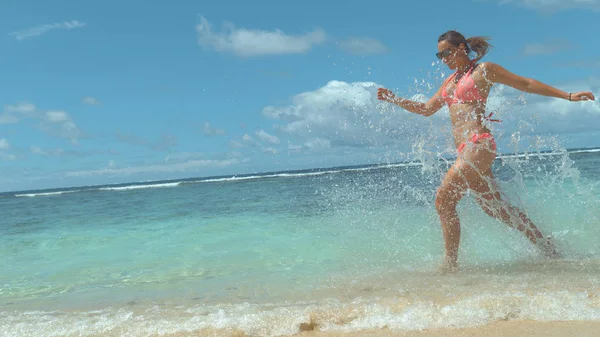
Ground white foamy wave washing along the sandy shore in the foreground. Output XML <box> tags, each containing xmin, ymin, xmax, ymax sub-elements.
<box><xmin>0</xmin><ymin>289</ymin><xmax>600</xmax><ymax>337</ymax></box>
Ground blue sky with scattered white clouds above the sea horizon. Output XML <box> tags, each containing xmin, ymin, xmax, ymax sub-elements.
<box><xmin>0</xmin><ymin>0</ymin><xmax>600</xmax><ymax>191</ymax></box>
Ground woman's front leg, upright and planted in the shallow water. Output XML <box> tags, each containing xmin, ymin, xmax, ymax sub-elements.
<box><xmin>435</xmin><ymin>139</ymin><xmax>496</xmax><ymax>271</ymax></box>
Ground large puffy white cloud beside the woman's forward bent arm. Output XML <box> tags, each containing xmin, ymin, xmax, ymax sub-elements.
<box><xmin>263</xmin><ymin>81</ymin><xmax>447</xmax><ymax>150</ymax></box>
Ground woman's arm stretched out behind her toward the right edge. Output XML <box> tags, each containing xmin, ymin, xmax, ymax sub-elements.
<box><xmin>482</xmin><ymin>62</ymin><xmax>596</xmax><ymax>101</ymax></box>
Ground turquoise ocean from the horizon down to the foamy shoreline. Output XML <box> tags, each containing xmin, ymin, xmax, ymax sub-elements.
<box><xmin>0</xmin><ymin>149</ymin><xmax>600</xmax><ymax>337</ymax></box>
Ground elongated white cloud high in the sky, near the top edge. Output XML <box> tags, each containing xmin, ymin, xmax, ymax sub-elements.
<box><xmin>196</xmin><ymin>17</ymin><xmax>326</xmax><ymax>57</ymax></box>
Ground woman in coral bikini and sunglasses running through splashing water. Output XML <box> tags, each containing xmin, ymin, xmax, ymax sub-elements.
<box><xmin>377</xmin><ymin>30</ymin><xmax>595</xmax><ymax>271</ymax></box>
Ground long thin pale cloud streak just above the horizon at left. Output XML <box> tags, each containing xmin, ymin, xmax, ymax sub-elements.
<box><xmin>65</xmin><ymin>158</ymin><xmax>240</xmax><ymax>177</ymax></box>
